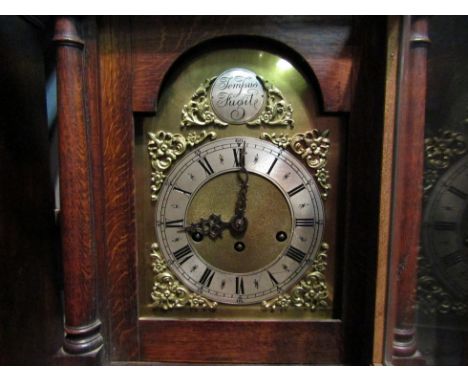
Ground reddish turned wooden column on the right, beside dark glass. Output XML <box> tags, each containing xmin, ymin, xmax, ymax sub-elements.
<box><xmin>391</xmin><ymin>17</ymin><xmax>429</xmax><ymax>364</ymax></box>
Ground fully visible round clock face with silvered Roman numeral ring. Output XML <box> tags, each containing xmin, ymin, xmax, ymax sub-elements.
<box><xmin>155</xmin><ymin>137</ymin><xmax>324</xmax><ymax>304</ymax></box>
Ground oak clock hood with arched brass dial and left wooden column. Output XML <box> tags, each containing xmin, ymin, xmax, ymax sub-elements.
<box><xmin>54</xmin><ymin>16</ymin><xmax>391</xmax><ymax>364</ymax></box>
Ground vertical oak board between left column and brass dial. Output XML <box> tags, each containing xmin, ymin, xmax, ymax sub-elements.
<box><xmin>98</xmin><ymin>17</ymin><xmax>139</xmax><ymax>361</ymax></box>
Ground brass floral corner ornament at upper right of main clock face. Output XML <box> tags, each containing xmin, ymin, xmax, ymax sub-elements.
<box><xmin>261</xmin><ymin>129</ymin><xmax>331</xmax><ymax>200</ymax></box>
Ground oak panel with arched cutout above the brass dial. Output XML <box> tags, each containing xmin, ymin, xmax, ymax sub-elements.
<box><xmin>132</xmin><ymin>16</ymin><xmax>353</xmax><ymax>112</ymax></box>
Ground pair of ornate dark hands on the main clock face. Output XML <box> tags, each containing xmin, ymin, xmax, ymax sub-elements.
<box><xmin>184</xmin><ymin>144</ymin><xmax>249</xmax><ymax>240</ymax></box>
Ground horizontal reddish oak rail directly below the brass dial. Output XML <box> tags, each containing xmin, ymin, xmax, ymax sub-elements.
<box><xmin>140</xmin><ymin>320</ymin><xmax>343</xmax><ymax>364</ymax></box>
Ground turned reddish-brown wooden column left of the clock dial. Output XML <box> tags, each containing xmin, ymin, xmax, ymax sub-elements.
<box><xmin>54</xmin><ymin>17</ymin><xmax>103</xmax><ymax>355</ymax></box>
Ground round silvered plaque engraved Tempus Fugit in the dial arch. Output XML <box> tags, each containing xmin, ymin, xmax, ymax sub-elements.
<box><xmin>211</xmin><ymin>68</ymin><xmax>265</xmax><ymax>124</ymax></box>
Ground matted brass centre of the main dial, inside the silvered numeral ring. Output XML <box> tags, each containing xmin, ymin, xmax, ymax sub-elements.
<box><xmin>185</xmin><ymin>171</ymin><xmax>292</xmax><ymax>274</ymax></box>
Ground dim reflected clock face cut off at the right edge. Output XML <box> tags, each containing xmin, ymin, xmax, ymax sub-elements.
<box><xmin>423</xmin><ymin>157</ymin><xmax>468</xmax><ymax>298</ymax></box>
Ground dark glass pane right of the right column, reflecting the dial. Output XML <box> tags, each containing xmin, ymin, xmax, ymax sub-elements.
<box><xmin>416</xmin><ymin>16</ymin><xmax>468</xmax><ymax>365</ymax></box>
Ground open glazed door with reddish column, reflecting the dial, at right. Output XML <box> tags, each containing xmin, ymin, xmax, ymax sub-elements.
<box><xmin>384</xmin><ymin>16</ymin><xmax>468</xmax><ymax>365</ymax></box>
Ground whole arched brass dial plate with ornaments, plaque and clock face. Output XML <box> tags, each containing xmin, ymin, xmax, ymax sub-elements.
<box><xmin>140</xmin><ymin>56</ymin><xmax>338</xmax><ymax>319</ymax></box>
